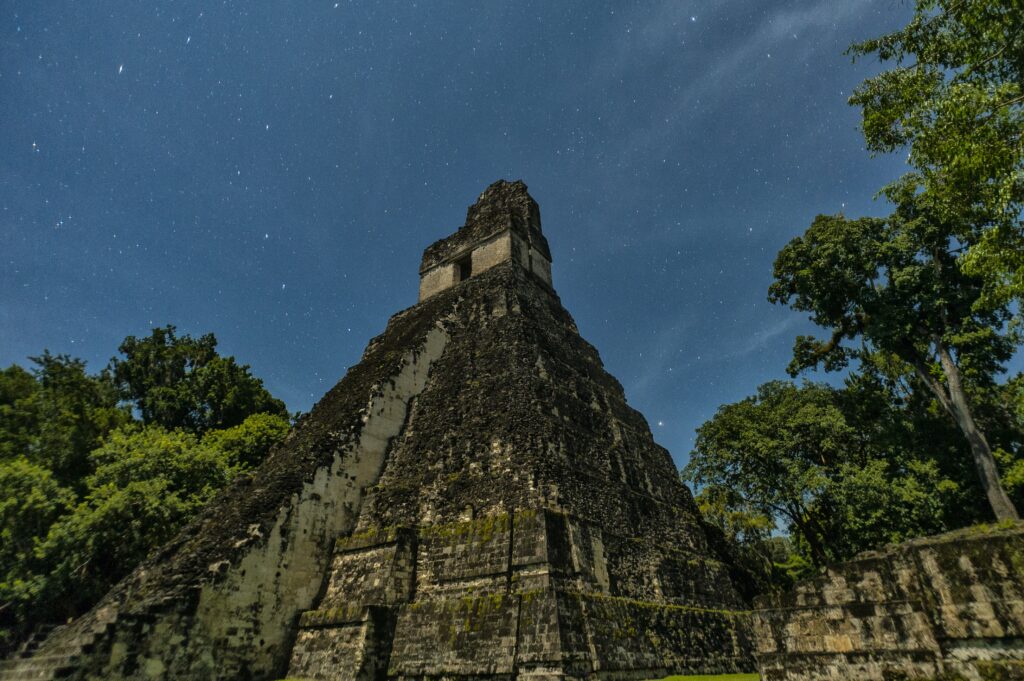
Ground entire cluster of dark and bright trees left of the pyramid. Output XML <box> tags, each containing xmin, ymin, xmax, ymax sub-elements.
<box><xmin>0</xmin><ymin>327</ymin><xmax>290</xmax><ymax>649</ymax></box>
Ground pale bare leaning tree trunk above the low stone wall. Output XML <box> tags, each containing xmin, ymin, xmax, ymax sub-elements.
<box><xmin>933</xmin><ymin>339</ymin><xmax>1020</xmax><ymax>520</ymax></box>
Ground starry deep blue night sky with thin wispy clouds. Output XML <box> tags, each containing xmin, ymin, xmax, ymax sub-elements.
<box><xmin>6</xmin><ymin>0</ymin><xmax>909</xmax><ymax>464</ymax></box>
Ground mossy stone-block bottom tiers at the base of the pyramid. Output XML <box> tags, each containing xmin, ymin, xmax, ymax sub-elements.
<box><xmin>289</xmin><ymin>503</ymin><xmax>750</xmax><ymax>681</ymax></box>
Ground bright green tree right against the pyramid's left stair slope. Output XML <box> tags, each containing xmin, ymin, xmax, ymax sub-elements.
<box><xmin>27</xmin><ymin>414</ymin><xmax>289</xmax><ymax>621</ymax></box>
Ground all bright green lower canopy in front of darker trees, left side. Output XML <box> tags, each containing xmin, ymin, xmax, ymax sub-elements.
<box><xmin>0</xmin><ymin>414</ymin><xmax>289</xmax><ymax>647</ymax></box>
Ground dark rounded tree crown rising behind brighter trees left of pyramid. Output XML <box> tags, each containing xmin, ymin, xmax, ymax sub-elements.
<box><xmin>110</xmin><ymin>326</ymin><xmax>288</xmax><ymax>433</ymax></box>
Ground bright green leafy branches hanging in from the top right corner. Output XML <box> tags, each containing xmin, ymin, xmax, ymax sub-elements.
<box><xmin>850</xmin><ymin>0</ymin><xmax>1024</xmax><ymax>302</ymax></box>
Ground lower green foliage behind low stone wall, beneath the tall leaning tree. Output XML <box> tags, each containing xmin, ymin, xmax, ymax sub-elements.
<box><xmin>683</xmin><ymin>355</ymin><xmax>1024</xmax><ymax>590</ymax></box>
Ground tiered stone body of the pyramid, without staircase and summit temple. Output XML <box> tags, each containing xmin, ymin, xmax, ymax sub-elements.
<box><xmin>289</xmin><ymin>266</ymin><xmax>752</xmax><ymax>680</ymax></box>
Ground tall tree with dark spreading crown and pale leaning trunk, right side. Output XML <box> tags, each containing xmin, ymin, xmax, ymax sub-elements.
<box><xmin>769</xmin><ymin>201</ymin><xmax>1018</xmax><ymax>519</ymax></box>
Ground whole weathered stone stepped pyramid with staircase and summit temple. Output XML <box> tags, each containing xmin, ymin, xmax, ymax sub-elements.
<box><xmin>0</xmin><ymin>181</ymin><xmax>753</xmax><ymax>681</ymax></box>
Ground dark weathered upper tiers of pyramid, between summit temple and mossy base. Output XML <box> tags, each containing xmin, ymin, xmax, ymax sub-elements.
<box><xmin>356</xmin><ymin>268</ymin><xmax>746</xmax><ymax>609</ymax></box>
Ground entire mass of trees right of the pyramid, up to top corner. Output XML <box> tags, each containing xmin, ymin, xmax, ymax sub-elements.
<box><xmin>683</xmin><ymin>0</ymin><xmax>1024</xmax><ymax>588</ymax></box>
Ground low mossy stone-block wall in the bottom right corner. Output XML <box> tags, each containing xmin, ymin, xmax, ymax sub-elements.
<box><xmin>754</xmin><ymin>523</ymin><xmax>1024</xmax><ymax>681</ymax></box>
